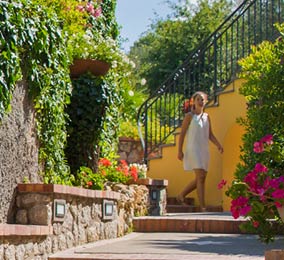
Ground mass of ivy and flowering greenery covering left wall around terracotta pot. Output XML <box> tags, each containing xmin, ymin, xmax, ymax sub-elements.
<box><xmin>0</xmin><ymin>0</ymin><xmax>135</xmax><ymax>184</ymax></box>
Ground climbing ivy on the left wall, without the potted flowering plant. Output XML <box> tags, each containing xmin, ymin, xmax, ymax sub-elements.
<box><xmin>0</xmin><ymin>0</ymin><xmax>127</xmax><ymax>184</ymax></box>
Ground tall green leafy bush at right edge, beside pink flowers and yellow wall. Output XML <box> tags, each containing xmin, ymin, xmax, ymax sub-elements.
<box><xmin>226</xmin><ymin>24</ymin><xmax>284</xmax><ymax>243</ymax></box>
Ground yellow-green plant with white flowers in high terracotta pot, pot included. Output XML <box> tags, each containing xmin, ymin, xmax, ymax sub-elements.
<box><xmin>38</xmin><ymin>0</ymin><xmax>124</xmax><ymax>77</ymax></box>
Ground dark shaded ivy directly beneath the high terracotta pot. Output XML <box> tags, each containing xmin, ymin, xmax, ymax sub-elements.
<box><xmin>66</xmin><ymin>74</ymin><xmax>112</xmax><ymax>173</ymax></box>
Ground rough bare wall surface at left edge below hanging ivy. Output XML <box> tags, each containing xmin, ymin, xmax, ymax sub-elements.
<box><xmin>0</xmin><ymin>82</ymin><xmax>40</xmax><ymax>223</ymax></box>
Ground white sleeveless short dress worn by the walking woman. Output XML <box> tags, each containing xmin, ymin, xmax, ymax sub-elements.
<box><xmin>183</xmin><ymin>113</ymin><xmax>209</xmax><ymax>172</ymax></box>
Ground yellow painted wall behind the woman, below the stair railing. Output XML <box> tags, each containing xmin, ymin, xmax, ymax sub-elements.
<box><xmin>148</xmin><ymin>80</ymin><xmax>246</xmax><ymax>211</ymax></box>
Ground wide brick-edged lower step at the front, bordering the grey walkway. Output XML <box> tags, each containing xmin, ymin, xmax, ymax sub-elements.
<box><xmin>133</xmin><ymin>212</ymin><xmax>246</xmax><ymax>234</ymax></box>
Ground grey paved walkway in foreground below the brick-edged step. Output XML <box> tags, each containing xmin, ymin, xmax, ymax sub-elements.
<box><xmin>51</xmin><ymin>232</ymin><xmax>284</xmax><ymax>260</ymax></box>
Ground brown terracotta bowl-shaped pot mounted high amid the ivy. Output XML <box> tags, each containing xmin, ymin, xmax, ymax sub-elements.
<box><xmin>70</xmin><ymin>59</ymin><xmax>110</xmax><ymax>78</ymax></box>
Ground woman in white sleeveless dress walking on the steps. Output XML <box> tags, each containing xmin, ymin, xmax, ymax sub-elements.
<box><xmin>177</xmin><ymin>92</ymin><xmax>223</xmax><ymax>211</ymax></box>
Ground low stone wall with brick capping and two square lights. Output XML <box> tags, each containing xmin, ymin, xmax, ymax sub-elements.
<box><xmin>0</xmin><ymin>184</ymin><xmax>149</xmax><ymax>260</ymax></box>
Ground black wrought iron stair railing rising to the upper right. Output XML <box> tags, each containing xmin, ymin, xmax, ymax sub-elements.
<box><xmin>137</xmin><ymin>0</ymin><xmax>284</xmax><ymax>162</ymax></box>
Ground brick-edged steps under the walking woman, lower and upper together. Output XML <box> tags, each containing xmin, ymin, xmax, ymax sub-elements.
<box><xmin>133</xmin><ymin>198</ymin><xmax>245</xmax><ymax>234</ymax></box>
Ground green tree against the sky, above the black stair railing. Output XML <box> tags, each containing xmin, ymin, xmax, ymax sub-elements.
<box><xmin>130</xmin><ymin>0</ymin><xmax>230</xmax><ymax>93</ymax></box>
